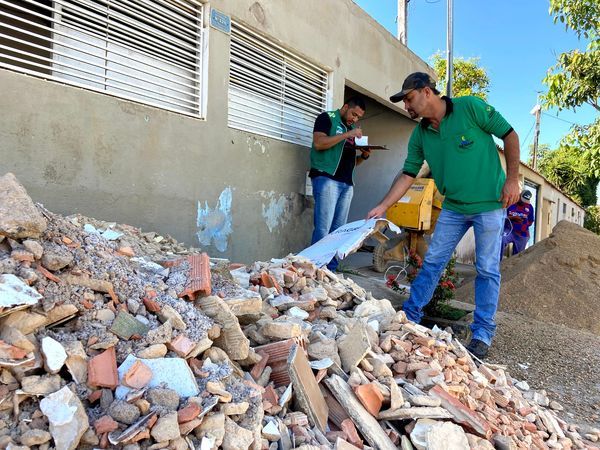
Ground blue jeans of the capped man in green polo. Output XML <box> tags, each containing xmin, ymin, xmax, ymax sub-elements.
<box><xmin>402</xmin><ymin>209</ymin><xmax>506</xmax><ymax>345</ymax></box>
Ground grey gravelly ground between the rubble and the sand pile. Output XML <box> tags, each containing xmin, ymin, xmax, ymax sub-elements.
<box><xmin>343</xmin><ymin>253</ymin><xmax>600</xmax><ymax>430</ymax></box>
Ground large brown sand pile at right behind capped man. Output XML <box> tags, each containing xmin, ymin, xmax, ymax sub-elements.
<box><xmin>456</xmin><ymin>221</ymin><xmax>600</xmax><ymax>335</ymax></box>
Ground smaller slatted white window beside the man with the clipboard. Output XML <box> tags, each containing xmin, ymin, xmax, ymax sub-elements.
<box><xmin>229</xmin><ymin>22</ymin><xmax>328</xmax><ymax>146</ymax></box>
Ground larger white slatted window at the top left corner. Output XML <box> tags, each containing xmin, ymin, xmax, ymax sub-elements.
<box><xmin>0</xmin><ymin>0</ymin><xmax>204</xmax><ymax>116</ymax></box>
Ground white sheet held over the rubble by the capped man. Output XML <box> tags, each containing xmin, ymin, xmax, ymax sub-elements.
<box><xmin>298</xmin><ymin>219</ymin><xmax>400</xmax><ymax>267</ymax></box>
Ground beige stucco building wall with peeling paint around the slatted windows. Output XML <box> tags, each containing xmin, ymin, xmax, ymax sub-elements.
<box><xmin>0</xmin><ymin>0</ymin><xmax>430</xmax><ymax>262</ymax></box>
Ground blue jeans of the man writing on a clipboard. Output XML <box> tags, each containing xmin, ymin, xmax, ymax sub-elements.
<box><xmin>311</xmin><ymin>177</ymin><xmax>354</xmax><ymax>270</ymax></box>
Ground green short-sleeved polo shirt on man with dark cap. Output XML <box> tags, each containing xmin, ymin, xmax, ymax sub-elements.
<box><xmin>403</xmin><ymin>97</ymin><xmax>512</xmax><ymax>214</ymax></box>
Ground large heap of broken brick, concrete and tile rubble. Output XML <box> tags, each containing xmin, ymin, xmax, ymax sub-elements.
<box><xmin>0</xmin><ymin>174</ymin><xmax>600</xmax><ymax>450</ymax></box>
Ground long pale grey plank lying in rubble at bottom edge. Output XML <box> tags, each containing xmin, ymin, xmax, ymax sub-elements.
<box><xmin>325</xmin><ymin>375</ymin><xmax>396</xmax><ymax>450</ymax></box>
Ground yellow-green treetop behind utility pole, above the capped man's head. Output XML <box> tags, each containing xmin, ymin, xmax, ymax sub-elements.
<box><xmin>431</xmin><ymin>52</ymin><xmax>490</xmax><ymax>100</ymax></box>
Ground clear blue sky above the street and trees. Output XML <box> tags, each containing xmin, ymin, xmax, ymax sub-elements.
<box><xmin>354</xmin><ymin>0</ymin><xmax>596</xmax><ymax>160</ymax></box>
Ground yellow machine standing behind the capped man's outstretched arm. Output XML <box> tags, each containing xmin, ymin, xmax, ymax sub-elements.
<box><xmin>373</xmin><ymin>178</ymin><xmax>444</xmax><ymax>272</ymax></box>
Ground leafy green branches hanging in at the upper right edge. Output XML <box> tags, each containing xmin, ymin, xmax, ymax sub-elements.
<box><xmin>543</xmin><ymin>0</ymin><xmax>600</xmax><ymax>178</ymax></box>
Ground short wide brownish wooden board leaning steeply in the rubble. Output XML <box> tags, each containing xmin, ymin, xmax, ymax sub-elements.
<box><xmin>288</xmin><ymin>344</ymin><xmax>329</xmax><ymax>433</ymax></box>
